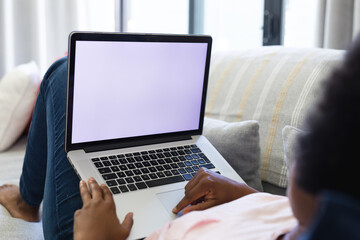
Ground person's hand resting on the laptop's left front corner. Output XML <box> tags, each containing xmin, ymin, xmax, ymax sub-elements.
<box><xmin>74</xmin><ymin>178</ymin><xmax>133</xmax><ymax>240</ymax></box>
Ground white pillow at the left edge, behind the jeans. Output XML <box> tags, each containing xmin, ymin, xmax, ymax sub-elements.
<box><xmin>0</xmin><ymin>62</ymin><xmax>40</xmax><ymax>151</ymax></box>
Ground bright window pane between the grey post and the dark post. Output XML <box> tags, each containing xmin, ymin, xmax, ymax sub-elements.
<box><xmin>203</xmin><ymin>0</ymin><xmax>264</xmax><ymax>51</ymax></box>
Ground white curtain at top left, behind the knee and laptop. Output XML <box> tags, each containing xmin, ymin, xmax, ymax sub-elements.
<box><xmin>0</xmin><ymin>0</ymin><xmax>115</xmax><ymax>78</ymax></box>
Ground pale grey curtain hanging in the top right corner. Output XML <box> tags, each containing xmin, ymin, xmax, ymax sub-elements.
<box><xmin>316</xmin><ymin>0</ymin><xmax>360</xmax><ymax>49</ymax></box>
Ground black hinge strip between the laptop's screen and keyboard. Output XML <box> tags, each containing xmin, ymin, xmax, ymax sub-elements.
<box><xmin>84</xmin><ymin>136</ymin><xmax>192</xmax><ymax>153</ymax></box>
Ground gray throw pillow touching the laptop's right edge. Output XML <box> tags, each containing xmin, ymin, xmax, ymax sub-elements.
<box><xmin>203</xmin><ymin>118</ymin><xmax>262</xmax><ymax>191</ymax></box>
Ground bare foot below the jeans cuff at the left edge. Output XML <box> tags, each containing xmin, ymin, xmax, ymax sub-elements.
<box><xmin>0</xmin><ymin>184</ymin><xmax>40</xmax><ymax>222</ymax></box>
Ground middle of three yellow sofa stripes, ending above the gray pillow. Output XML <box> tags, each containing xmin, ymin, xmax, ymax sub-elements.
<box><xmin>236</xmin><ymin>52</ymin><xmax>276</xmax><ymax>121</ymax></box>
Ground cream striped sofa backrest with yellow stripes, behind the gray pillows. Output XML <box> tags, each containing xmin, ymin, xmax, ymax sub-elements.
<box><xmin>206</xmin><ymin>46</ymin><xmax>344</xmax><ymax>187</ymax></box>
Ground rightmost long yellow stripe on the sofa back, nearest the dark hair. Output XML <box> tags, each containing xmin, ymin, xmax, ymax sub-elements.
<box><xmin>261</xmin><ymin>53</ymin><xmax>314</xmax><ymax>180</ymax></box>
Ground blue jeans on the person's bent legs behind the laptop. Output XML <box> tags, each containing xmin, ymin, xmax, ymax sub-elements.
<box><xmin>20</xmin><ymin>58</ymin><xmax>82</xmax><ymax>239</ymax></box>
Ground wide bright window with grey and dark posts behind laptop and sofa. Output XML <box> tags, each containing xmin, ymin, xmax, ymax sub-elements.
<box><xmin>116</xmin><ymin>0</ymin><xmax>283</xmax><ymax>51</ymax></box>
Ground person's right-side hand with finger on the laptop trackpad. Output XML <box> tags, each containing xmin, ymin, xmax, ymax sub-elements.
<box><xmin>173</xmin><ymin>168</ymin><xmax>257</xmax><ymax>214</ymax></box>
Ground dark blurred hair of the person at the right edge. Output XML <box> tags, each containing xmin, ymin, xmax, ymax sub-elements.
<box><xmin>295</xmin><ymin>35</ymin><xmax>360</xmax><ymax>200</ymax></box>
